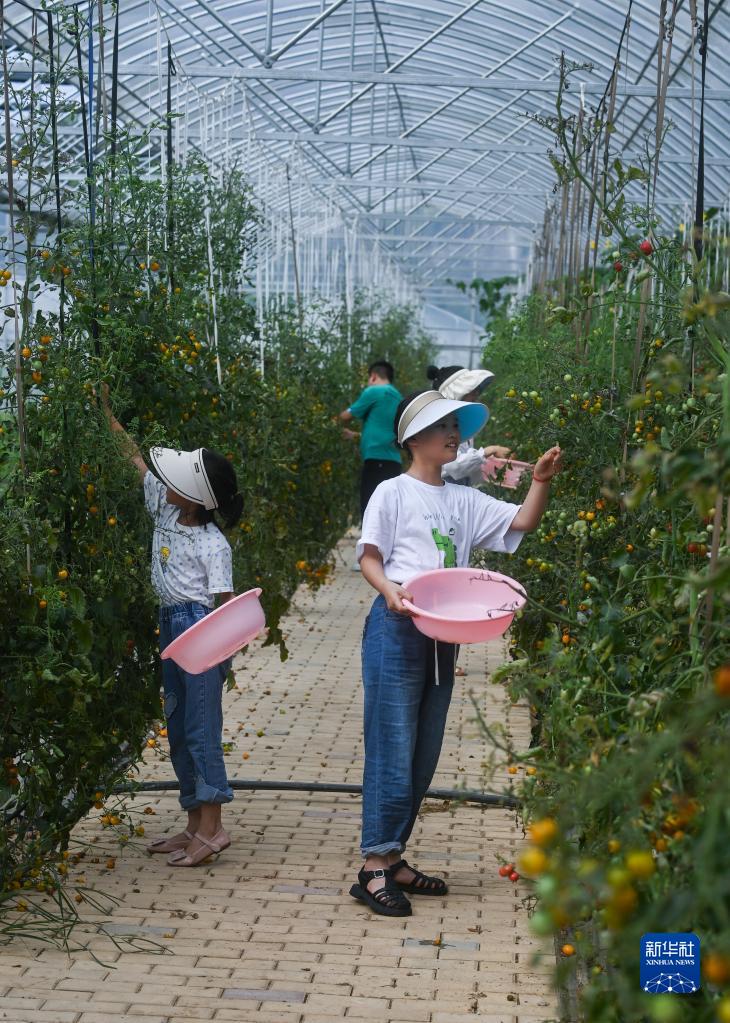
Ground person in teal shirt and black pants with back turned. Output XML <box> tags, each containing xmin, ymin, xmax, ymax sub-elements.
<box><xmin>339</xmin><ymin>360</ymin><xmax>402</xmax><ymax>515</ymax></box>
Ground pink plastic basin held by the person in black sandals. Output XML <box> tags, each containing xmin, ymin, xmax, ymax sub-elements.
<box><xmin>403</xmin><ymin>569</ymin><xmax>526</xmax><ymax>643</ymax></box>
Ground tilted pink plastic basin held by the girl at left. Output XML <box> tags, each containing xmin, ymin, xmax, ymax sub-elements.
<box><xmin>161</xmin><ymin>588</ymin><xmax>266</xmax><ymax>675</ymax></box>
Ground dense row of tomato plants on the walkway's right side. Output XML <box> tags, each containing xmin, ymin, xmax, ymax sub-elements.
<box><xmin>468</xmin><ymin>171</ymin><xmax>730</xmax><ymax>1023</ymax></box>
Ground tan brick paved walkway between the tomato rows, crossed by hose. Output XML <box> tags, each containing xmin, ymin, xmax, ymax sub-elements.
<box><xmin>0</xmin><ymin>540</ymin><xmax>557</xmax><ymax>1023</ymax></box>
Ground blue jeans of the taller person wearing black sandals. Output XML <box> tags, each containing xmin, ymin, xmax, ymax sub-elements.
<box><xmin>361</xmin><ymin>596</ymin><xmax>456</xmax><ymax>856</ymax></box>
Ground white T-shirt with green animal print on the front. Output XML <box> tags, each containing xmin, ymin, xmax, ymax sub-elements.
<box><xmin>357</xmin><ymin>473</ymin><xmax>524</xmax><ymax>583</ymax></box>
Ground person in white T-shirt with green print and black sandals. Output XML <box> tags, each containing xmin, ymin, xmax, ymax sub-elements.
<box><xmin>350</xmin><ymin>391</ymin><xmax>561</xmax><ymax>917</ymax></box>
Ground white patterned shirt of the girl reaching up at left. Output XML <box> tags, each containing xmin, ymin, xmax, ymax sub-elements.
<box><xmin>144</xmin><ymin>472</ymin><xmax>233</xmax><ymax>608</ymax></box>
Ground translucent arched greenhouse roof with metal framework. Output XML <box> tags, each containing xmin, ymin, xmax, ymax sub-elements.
<box><xmin>6</xmin><ymin>0</ymin><xmax>730</xmax><ymax>319</ymax></box>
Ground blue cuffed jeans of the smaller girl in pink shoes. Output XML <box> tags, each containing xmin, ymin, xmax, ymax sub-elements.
<box><xmin>159</xmin><ymin>602</ymin><xmax>233</xmax><ymax>810</ymax></box>
